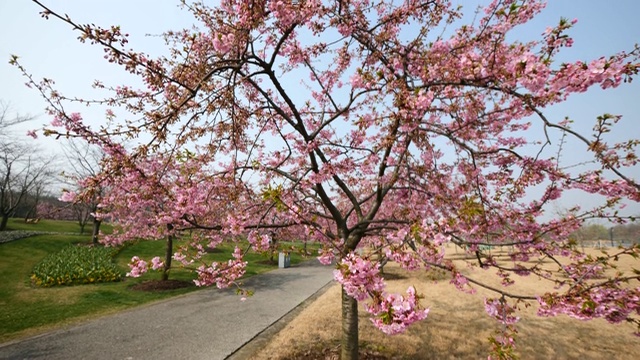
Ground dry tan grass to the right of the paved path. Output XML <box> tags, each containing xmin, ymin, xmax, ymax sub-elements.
<box><xmin>252</xmin><ymin>248</ymin><xmax>640</xmax><ymax>360</ymax></box>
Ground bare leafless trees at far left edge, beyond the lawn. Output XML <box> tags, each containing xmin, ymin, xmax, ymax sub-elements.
<box><xmin>0</xmin><ymin>100</ymin><xmax>102</xmax><ymax>233</ymax></box>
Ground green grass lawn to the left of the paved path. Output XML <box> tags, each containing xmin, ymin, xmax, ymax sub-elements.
<box><xmin>0</xmin><ymin>221</ymin><xmax>318</xmax><ymax>343</ymax></box>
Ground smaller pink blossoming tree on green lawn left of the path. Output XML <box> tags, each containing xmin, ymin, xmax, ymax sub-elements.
<box><xmin>99</xmin><ymin>152</ymin><xmax>249</xmax><ymax>280</ymax></box>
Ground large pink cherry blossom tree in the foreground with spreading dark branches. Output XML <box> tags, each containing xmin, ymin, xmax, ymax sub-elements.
<box><xmin>12</xmin><ymin>0</ymin><xmax>640</xmax><ymax>359</ymax></box>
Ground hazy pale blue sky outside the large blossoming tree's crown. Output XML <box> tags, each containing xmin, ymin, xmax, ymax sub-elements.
<box><xmin>0</xmin><ymin>0</ymin><xmax>640</xmax><ymax>219</ymax></box>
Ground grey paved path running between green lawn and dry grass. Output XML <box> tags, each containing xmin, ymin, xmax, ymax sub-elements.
<box><xmin>0</xmin><ymin>260</ymin><xmax>333</xmax><ymax>360</ymax></box>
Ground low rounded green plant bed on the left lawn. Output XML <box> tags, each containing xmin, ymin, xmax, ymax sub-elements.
<box><xmin>31</xmin><ymin>245</ymin><xmax>122</xmax><ymax>287</ymax></box>
